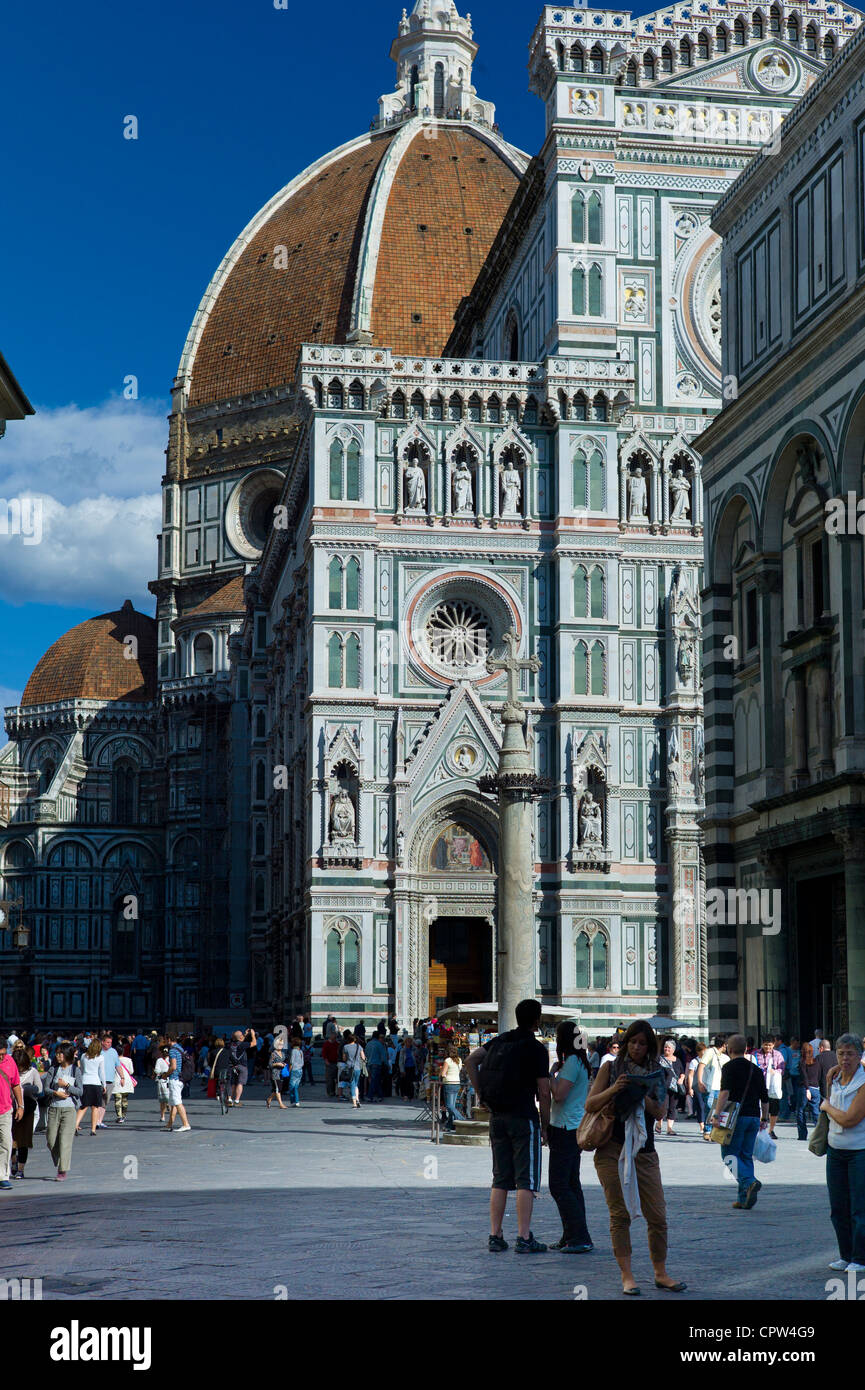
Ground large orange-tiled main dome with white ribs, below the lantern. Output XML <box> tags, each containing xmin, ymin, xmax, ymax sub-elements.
<box><xmin>179</xmin><ymin>121</ymin><xmax>526</xmax><ymax>406</ymax></box>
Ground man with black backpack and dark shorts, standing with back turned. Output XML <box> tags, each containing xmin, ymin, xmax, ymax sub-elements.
<box><xmin>466</xmin><ymin>999</ymin><xmax>549</xmax><ymax>1255</ymax></box>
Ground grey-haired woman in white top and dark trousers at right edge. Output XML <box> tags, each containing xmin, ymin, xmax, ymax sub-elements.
<box><xmin>820</xmin><ymin>1033</ymin><xmax>865</xmax><ymax>1270</ymax></box>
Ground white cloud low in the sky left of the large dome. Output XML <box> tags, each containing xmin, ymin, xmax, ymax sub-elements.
<box><xmin>0</xmin><ymin>400</ymin><xmax>168</xmax><ymax>613</ymax></box>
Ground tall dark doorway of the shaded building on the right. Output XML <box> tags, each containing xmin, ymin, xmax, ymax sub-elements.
<box><xmin>790</xmin><ymin>874</ymin><xmax>847</xmax><ymax>1041</ymax></box>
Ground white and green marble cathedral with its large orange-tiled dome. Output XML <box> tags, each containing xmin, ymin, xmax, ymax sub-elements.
<box><xmin>0</xmin><ymin>0</ymin><xmax>859</xmax><ymax>1030</ymax></box>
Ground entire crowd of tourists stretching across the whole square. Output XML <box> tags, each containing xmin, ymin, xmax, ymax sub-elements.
<box><xmin>0</xmin><ymin>999</ymin><xmax>865</xmax><ymax>1297</ymax></box>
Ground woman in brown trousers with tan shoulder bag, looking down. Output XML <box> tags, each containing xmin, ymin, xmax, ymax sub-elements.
<box><xmin>585</xmin><ymin>1019</ymin><xmax>686</xmax><ymax>1297</ymax></box>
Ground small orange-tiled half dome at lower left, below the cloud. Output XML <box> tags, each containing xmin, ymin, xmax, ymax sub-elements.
<box><xmin>21</xmin><ymin>599</ymin><xmax>156</xmax><ymax>705</ymax></box>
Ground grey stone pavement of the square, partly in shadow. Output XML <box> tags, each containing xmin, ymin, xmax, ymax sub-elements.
<box><xmin>0</xmin><ymin>1081</ymin><xmax>837</xmax><ymax>1304</ymax></box>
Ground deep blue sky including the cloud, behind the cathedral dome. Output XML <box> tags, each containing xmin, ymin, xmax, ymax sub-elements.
<box><xmin>0</xmin><ymin>0</ymin><xmax>650</xmax><ymax>705</ymax></box>
